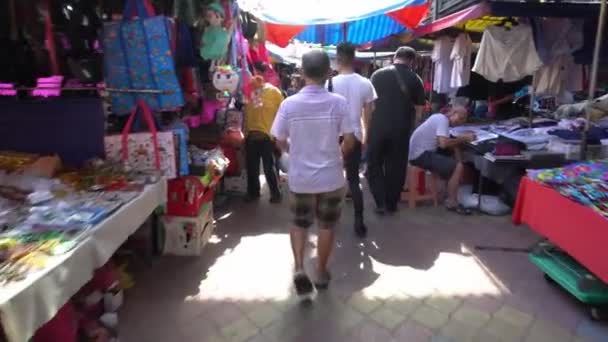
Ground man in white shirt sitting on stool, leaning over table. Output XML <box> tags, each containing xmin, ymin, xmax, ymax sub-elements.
<box><xmin>409</xmin><ymin>106</ymin><xmax>475</xmax><ymax>214</ymax></box>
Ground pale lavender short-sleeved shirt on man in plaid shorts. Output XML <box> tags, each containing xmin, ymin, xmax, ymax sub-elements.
<box><xmin>271</xmin><ymin>86</ymin><xmax>354</xmax><ymax>194</ymax></box>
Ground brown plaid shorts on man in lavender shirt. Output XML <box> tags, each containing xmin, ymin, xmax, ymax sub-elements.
<box><xmin>289</xmin><ymin>188</ymin><xmax>345</xmax><ymax>228</ymax></box>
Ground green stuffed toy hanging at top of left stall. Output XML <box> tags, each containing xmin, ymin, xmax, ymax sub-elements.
<box><xmin>200</xmin><ymin>2</ymin><xmax>230</xmax><ymax>62</ymax></box>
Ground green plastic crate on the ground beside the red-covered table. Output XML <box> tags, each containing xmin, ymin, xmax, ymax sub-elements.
<box><xmin>529</xmin><ymin>242</ymin><xmax>608</xmax><ymax>305</ymax></box>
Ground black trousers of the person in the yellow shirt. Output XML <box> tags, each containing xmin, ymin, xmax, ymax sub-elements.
<box><xmin>245</xmin><ymin>134</ymin><xmax>281</xmax><ymax>197</ymax></box>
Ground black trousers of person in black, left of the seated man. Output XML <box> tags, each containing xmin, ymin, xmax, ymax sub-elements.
<box><xmin>367</xmin><ymin>131</ymin><xmax>409</xmax><ymax>210</ymax></box>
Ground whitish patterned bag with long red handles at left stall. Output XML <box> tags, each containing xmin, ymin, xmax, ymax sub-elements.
<box><xmin>104</xmin><ymin>100</ymin><xmax>177</xmax><ymax>179</ymax></box>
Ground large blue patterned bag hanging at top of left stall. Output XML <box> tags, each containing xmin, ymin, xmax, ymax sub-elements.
<box><xmin>103</xmin><ymin>0</ymin><xmax>184</xmax><ymax>115</ymax></box>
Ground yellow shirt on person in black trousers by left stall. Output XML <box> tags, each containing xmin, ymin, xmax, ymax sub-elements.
<box><xmin>245</xmin><ymin>83</ymin><xmax>283</xmax><ymax>135</ymax></box>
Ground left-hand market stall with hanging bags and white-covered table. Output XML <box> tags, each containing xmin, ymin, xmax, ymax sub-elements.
<box><xmin>0</xmin><ymin>0</ymin><xmax>249</xmax><ymax>342</ymax></box>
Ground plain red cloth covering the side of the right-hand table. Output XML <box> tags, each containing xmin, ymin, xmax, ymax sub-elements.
<box><xmin>513</xmin><ymin>177</ymin><xmax>608</xmax><ymax>283</ymax></box>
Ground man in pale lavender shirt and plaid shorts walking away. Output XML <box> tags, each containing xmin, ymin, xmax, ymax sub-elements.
<box><xmin>271</xmin><ymin>50</ymin><xmax>355</xmax><ymax>295</ymax></box>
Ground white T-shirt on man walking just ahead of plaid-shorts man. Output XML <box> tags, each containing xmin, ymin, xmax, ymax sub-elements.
<box><xmin>332</xmin><ymin>73</ymin><xmax>378</xmax><ymax>141</ymax></box>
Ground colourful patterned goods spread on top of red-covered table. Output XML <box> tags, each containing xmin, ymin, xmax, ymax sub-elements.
<box><xmin>528</xmin><ymin>160</ymin><xmax>608</xmax><ymax>218</ymax></box>
